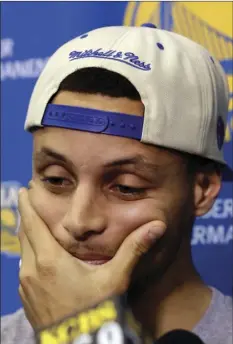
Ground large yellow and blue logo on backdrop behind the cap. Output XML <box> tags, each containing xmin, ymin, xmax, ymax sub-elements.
<box><xmin>124</xmin><ymin>1</ymin><xmax>233</xmax><ymax>142</ymax></box>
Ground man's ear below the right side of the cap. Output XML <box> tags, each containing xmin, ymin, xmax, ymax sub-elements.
<box><xmin>194</xmin><ymin>173</ymin><xmax>221</xmax><ymax>216</ymax></box>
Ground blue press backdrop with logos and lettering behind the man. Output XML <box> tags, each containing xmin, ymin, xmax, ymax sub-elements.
<box><xmin>1</xmin><ymin>2</ymin><xmax>233</xmax><ymax>314</ymax></box>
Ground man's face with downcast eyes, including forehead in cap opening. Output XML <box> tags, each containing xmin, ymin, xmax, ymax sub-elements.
<box><xmin>30</xmin><ymin>92</ymin><xmax>193</xmax><ymax>290</ymax></box>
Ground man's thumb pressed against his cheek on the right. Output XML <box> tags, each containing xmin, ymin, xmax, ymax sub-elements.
<box><xmin>110</xmin><ymin>220</ymin><xmax>166</xmax><ymax>283</ymax></box>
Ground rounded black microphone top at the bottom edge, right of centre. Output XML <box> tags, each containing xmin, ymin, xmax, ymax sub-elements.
<box><xmin>156</xmin><ymin>330</ymin><xmax>204</xmax><ymax>344</ymax></box>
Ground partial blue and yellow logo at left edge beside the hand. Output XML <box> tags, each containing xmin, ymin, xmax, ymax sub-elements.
<box><xmin>1</xmin><ymin>181</ymin><xmax>21</xmax><ymax>257</ymax></box>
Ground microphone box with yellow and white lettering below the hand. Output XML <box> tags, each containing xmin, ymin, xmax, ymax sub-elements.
<box><xmin>36</xmin><ymin>296</ymin><xmax>154</xmax><ymax>344</ymax></box>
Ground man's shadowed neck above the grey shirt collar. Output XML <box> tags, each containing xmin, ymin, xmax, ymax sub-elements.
<box><xmin>131</xmin><ymin>238</ymin><xmax>212</xmax><ymax>338</ymax></box>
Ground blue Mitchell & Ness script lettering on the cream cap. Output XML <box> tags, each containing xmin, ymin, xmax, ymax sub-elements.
<box><xmin>69</xmin><ymin>48</ymin><xmax>151</xmax><ymax>71</ymax></box>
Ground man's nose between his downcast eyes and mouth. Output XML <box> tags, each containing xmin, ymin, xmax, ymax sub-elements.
<box><xmin>63</xmin><ymin>185</ymin><xmax>107</xmax><ymax>241</ymax></box>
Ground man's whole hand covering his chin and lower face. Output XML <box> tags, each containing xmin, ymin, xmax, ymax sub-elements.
<box><xmin>19</xmin><ymin>189</ymin><xmax>165</xmax><ymax>329</ymax></box>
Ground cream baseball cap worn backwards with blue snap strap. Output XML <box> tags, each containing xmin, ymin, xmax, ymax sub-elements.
<box><xmin>25</xmin><ymin>24</ymin><xmax>230</xmax><ymax>180</ymax></box>
